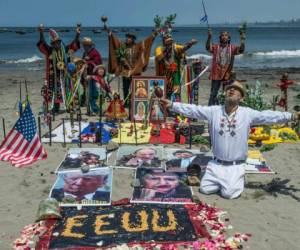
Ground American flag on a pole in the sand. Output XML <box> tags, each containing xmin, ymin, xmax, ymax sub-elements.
<box><xmin>0</xmin><ymin>103</ymin><xmax>47</xmax><ymax>167</ymax></box>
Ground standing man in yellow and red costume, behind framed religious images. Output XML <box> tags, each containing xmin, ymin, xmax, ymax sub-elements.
<box><xmin>155</xmin><ymin>33</ymin><xmax>197</xmax><ymax>98</ymax></box>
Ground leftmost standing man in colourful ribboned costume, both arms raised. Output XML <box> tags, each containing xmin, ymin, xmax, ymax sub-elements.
<box><xmin>37</xmin><ymin>25</ymin><xmax>80</xmax><ymax>113</ymax></box>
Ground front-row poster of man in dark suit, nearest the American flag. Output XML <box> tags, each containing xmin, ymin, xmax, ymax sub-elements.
<box><xmin>49</xmin><ymin>167</ymin><xmax>112</xmax><ymax>206</ymax></box>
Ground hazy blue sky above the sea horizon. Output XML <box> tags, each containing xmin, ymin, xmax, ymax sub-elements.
<box><xmin>0</xmin><ymin>0</ymin><xmax>300</xmax><ymax>27</ymax></box>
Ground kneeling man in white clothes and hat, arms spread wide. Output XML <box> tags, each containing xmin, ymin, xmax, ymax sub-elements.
<box><xmin>161</xmin><ymin>81</ymin><xmax>300</xmax><ymax>199</ymax></box>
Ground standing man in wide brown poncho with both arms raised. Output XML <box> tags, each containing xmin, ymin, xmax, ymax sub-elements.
<box><xmin>104</xmin><ymin>17</ymin><xmax>158</xmax><ymax>111</ymax></box>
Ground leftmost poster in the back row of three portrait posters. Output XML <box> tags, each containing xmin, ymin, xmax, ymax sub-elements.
<box><xmin>56</xmin><ymin>148</ymin><xmax>106</xmax><ymax>172</ymax></box>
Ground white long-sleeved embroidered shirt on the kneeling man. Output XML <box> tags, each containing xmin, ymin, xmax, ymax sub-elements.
<box><xmin>172</xmin><ymin>103</ymin><xmax>292</xmax><ymax>161</ymax></box>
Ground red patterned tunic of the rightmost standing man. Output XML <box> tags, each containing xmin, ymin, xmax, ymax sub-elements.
<box><xmin>209</xmin><ymin>44</ymin><xmax>240</xmax><ymax>80</ymax></box>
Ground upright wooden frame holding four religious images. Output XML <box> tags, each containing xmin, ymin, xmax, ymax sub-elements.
<box><xmin>131</xmin><ymin>76</ymin><xmax>167</xmax><ymax>123</ymax></box>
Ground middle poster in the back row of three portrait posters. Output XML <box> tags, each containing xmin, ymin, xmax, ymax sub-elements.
<box><xmin>115</xmin><ymin>146</ymin><xmax>163</xmax><ymax>169</ymax></box>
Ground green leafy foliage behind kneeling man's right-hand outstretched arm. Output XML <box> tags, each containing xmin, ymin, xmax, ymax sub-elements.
<box><xmin>241</xmin><ymin>81</ymin><xmax>272</xmax><ymax>111</ymax></box>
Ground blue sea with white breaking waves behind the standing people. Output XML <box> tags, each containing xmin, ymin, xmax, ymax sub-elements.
<box><xmin>0</xmin><ymin>27</ymin><xmax>300</xmax><ymax>70</ymax></box>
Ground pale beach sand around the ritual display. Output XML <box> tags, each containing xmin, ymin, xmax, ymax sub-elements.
<box><xmin>0</xmin><ymin>69</ymin><xmax>300</xmax><ymax>250</ymax></box>
